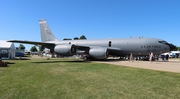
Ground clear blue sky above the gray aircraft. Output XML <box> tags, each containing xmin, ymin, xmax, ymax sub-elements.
<box><xmin>0</xmin><ymin>0</ymin><xmax>180</xmax><ymax>50</ymax></box>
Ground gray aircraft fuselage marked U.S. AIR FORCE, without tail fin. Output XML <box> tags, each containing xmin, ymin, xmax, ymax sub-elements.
<box><xmin>46</xmin><ymin>38</ymin><xmax>170</xmax><ymax>56</ymax></box>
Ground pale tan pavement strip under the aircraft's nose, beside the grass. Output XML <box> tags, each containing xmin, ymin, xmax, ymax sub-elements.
<box><xmin>98</xmin><ymin>60</ymin><xmax>180</xmax><ymax>73</ymax></box>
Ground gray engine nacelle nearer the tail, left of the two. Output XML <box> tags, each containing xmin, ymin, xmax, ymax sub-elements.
<box><xmin>54</xmin><ymin>44</ymin><xmax>76</xmax><ymax>56</ymax></box>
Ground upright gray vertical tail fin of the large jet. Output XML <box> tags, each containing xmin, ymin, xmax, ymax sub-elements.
<box><xmin>39</xmin><ymin>20</ymin><xmax>58</xmax><ymax>42</ymax></box>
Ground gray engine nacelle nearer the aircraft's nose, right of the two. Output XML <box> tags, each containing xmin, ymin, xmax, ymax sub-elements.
<box><xmin>89</xmin><ymin>48</ymin><xmax>109</xmax><ymax>59</ymax></box>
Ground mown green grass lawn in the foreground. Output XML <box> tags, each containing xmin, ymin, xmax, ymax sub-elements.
<box><xmin>0</xmin><ymin>58</ymin><xmax>180</xmax><ymax>99</ymax></box>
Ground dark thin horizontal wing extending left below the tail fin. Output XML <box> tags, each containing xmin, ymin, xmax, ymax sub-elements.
<box><xmin>7</xmin><ymin>40</ymin><xmax>55</xmax><ymax>45</ymax></box>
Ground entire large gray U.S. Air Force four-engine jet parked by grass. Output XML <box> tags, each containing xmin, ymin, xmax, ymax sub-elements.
<box><xmin>9</xmin><ymin>20</ymin><xmax>172</xmax><ymax>60</ymax></box>
